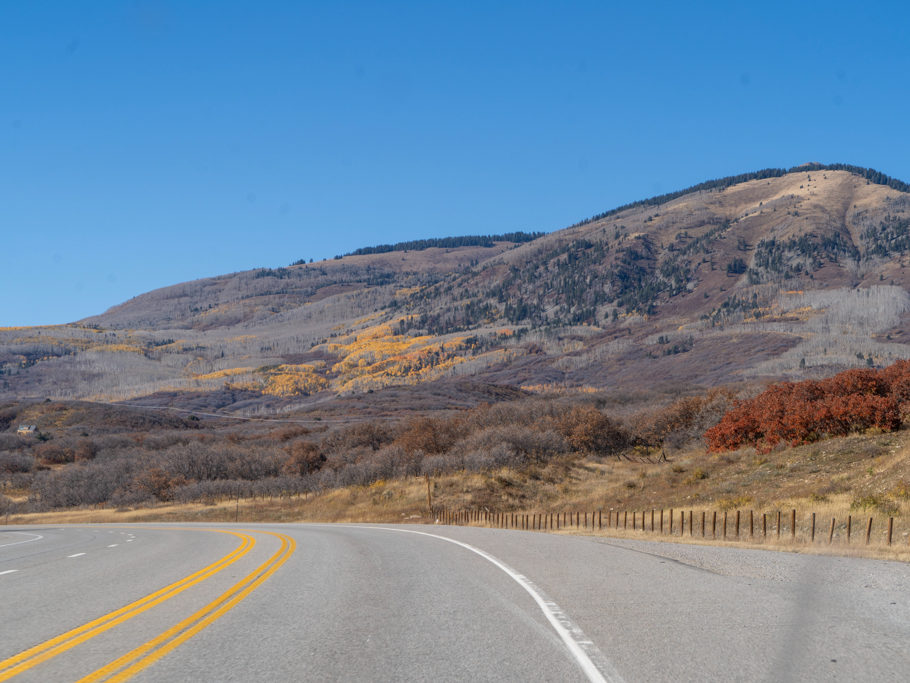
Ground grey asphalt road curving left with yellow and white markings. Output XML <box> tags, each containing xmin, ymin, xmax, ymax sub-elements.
<box><xmin>0</xmin><ymin>525</ymin><xmax>910</xmax><ymax>682</ymax></box>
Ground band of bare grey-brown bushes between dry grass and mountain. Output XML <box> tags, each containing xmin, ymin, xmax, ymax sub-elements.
<box><xmin>0</xmin><ymin>393</ymin><xmax>727</xmax><ymax>511</ymax></box>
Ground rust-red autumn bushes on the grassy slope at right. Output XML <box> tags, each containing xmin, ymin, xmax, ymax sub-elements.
<box><xmin>705</xmin><ymin>361</ymin><xmax>910</xmax><ymax>451</ymax></box>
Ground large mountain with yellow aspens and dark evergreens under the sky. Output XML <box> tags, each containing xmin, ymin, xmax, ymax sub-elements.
<box><xmin>0</xmin><ymin>164</ymin><xmax>910</xmax><ymax>414</ymax></box>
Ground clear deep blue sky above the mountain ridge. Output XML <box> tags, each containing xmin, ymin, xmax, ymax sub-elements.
<box><xmin>0</xmin><ymin>0</ymin><xmax>910</xmax><ymax>325</ymax></box>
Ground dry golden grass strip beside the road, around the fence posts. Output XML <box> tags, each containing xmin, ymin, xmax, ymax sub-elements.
<box><xmin>3</xmin><ymin>431</ymin><xmax>910</xmax><ymax>561</ymax></box>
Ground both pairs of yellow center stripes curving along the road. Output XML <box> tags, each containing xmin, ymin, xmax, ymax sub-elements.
<box><xmin>0</xmin><ymin>531</ymin><xmax>296</xmax><ymax>683</ymax></box>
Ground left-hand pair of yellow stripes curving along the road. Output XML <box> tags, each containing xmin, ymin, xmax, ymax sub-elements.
<box><xmin>0</xmin><ymin>530</ymin><xmax>256</xmax><ymax>683</ymax></box>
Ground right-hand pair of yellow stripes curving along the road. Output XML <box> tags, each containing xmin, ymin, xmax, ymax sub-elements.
<box><xmin>77</xmin><ymin>531</ymin><xmax>297</xmax><ymax>683</ymax></box>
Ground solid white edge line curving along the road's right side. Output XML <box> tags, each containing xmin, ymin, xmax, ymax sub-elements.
<box><xmin>352</xmin><ymin>525</ymin><xmax>622</xmax><ymax>683</ymax></box>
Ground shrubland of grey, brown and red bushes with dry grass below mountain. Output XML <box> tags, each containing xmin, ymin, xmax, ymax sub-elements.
<box><xmin>0</xmin><ymin>361</ymin><xmax>910</xmax><ymax>532</ymax></box>
